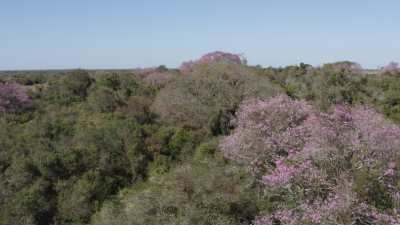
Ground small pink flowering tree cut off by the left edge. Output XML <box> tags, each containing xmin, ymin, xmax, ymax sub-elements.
<box><xmin>0</xmin><ymin>83</ymin><xmax>32</xmax><ymax>113</ymax></box>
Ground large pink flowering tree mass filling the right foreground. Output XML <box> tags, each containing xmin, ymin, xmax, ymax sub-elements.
<box><xmin>220</xmin><ymin>96</ymin><xmax>400</xmax><ymax>225</ymax></box>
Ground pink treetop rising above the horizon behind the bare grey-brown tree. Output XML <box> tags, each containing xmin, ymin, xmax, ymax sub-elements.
<box><xmin>180</xmin><ymin>51</ymin><xmax>246</xmax><ymax>74</ymax></box>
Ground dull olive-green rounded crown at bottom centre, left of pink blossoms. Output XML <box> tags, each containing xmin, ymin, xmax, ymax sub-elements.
<box><xmin>93</xmin><ymin>162</ymin><xmax>258</xmax><ymax>225</ymax></box>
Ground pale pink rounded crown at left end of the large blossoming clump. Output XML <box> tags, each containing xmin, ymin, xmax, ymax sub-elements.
<box><xmin>220</xmin><ymin>95</ymin><xmax>315</xmax><ymax>169</ymax></box>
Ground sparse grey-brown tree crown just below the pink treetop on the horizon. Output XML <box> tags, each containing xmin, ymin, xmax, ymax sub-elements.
<box><xmin>152</xmin><ymin>63</ymin><xmax>280</xmax><ymax>128</ymax></box>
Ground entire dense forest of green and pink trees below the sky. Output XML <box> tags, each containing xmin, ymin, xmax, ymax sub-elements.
<box><xmin>0</xmin><ymin>52</ymin><xmax>400</xmax><ymax>225</ymax></box>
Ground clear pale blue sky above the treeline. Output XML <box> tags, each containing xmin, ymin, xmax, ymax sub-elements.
<box><xmin>0</xmin><ymin>0</ymin><xmax>400</xmax><ymax>70</ymax></box>
